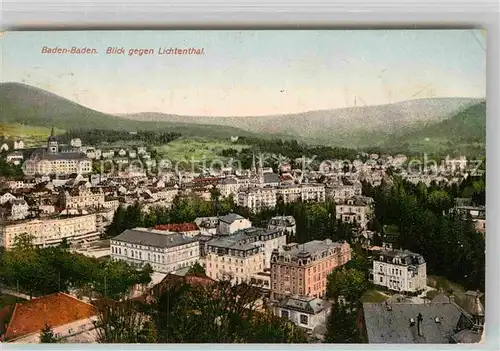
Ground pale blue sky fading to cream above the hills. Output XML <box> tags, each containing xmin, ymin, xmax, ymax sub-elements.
<box><xmin>0</xmin><ymin>30</ymin><xmax>486</xmax><ymax>116</ymax></box>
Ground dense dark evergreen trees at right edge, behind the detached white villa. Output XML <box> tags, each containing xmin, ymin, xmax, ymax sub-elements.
<box><xmin>363</xmin><ymin>175</ymin><xmax>485</xmax><ymax>291</ymax></box>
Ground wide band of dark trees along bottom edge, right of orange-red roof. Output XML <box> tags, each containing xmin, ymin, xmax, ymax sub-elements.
<box><xmin>91</xmin><ymin>281</ymin><xmax>307</xmax><ymax>343</ymax></box>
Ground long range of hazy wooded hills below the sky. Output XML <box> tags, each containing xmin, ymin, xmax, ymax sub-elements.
<box><xmin>0</xmin><ymin>83</ymin><xmax>486</xmax><ymax>152</ymax></box>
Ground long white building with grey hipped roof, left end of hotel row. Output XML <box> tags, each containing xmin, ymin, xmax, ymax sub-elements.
<box><xmin>110</xmin><ymin>228</ymin><xmax>200</xmax><ymax>273</ymax></box>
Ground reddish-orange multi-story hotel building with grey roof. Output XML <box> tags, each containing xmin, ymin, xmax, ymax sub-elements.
<box><xmin>271</xmin><ymin>239</ymin><xmax>351</xmax><ymax>300</ymax></box>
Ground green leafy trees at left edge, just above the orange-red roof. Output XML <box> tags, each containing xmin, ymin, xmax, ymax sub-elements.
<box><xmin>0</xmin><ymin>234</ymin><xmax>152</xmax><ymax>298</ymax></box>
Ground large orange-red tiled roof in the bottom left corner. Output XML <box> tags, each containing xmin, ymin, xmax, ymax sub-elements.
<box><xmin>4</xmin><ymin>293</ymin><xmax>97</xmax><ymax>340</ymax></box>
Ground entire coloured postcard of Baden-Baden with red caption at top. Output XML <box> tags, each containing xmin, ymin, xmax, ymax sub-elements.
<box><xmin>0</xmin><ymin>29</ymin><xmax>486</xmax><ymax>344</ymax></box>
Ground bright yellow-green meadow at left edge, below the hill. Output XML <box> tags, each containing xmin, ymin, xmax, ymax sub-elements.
<box><xmin>0</xmin><ymin>123</ymin><xmax>64</xmax><ymax>147</ymax></box>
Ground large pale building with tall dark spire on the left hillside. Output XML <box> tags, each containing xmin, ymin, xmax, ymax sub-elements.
<box><xmin>24</xmin><ymin>128</ymin><xmax>92</xmax><ymax>175</ymax></box>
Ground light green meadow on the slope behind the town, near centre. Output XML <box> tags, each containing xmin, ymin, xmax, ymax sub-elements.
<box><xmin>156</xmin><ymin>138</ymin><xmax>249</xmax><ymax>162</ymax></box>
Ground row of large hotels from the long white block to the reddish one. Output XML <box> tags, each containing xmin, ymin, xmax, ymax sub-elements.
<box><xmin>106</xmin><ymin>213</ymin><xmax>351</xmax><ymax>334</ymax></box>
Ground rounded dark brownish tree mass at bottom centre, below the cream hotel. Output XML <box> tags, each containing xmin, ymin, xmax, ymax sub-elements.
<box><xmin>152</xmin><ymin>280</ymin><xmax>306</xmax><ymax>343</ymax></box>
